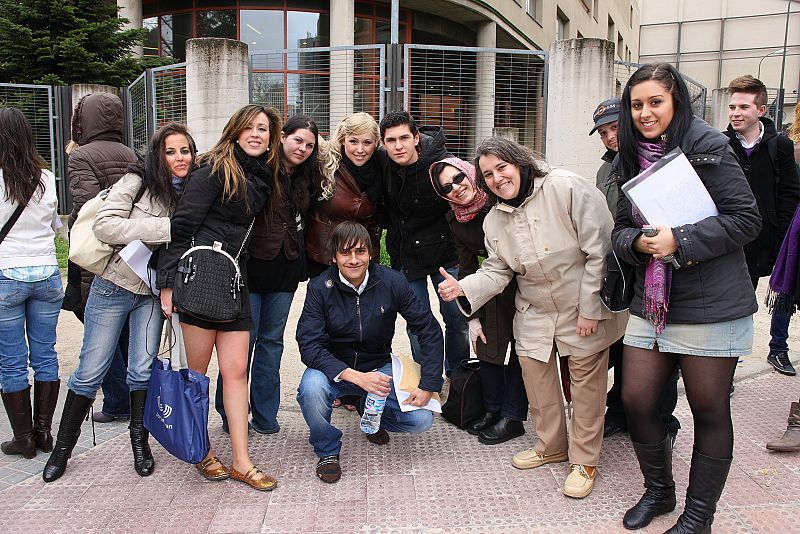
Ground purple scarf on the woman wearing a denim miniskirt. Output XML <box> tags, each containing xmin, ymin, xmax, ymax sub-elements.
<box><xmin>637</xmin><ymin>141</ymin><xmax>672</xmax><ymax>334</ymax></box>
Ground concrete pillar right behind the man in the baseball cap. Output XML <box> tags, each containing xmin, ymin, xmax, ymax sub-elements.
<box><xmin>545</xmin><ymin>39</ymin><xmax>614</xmax><ymax>181</ymax></box>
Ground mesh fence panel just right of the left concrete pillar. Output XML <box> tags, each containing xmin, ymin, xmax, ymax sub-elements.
<box><xmin>250</xmin><ymin>45</ymin><xmax>385</xmax><ymax>136</ymax></box>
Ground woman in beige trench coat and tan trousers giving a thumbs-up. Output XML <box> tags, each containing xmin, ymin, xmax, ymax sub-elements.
<box><xmin>439</xmin><ymin>137</ymin><xmax>627</xmax><ymax>498</ymax></box>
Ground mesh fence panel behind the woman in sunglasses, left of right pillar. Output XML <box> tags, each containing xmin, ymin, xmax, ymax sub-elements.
<box><xmin>405</xmin><ymin>45</ymin><xmax>547</xmax><ymax>159</ymax></box>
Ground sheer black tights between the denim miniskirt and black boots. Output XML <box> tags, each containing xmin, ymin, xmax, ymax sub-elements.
<box><xmin>622</xmin><ymin>345</ymin><xmax>738</xmax><ymax>458</ymax></box>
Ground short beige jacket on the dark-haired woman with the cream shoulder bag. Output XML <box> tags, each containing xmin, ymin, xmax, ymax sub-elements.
<box><xmin>92</xmin><ymin>173</ymin><xmax>170</xmax><ymax>295</ymax></box>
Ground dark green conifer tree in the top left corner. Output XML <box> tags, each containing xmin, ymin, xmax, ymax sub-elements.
<box><xmin>0</xmin><ymin>0</ymin><xmax>173</xmax><ymax>86</ymax></box>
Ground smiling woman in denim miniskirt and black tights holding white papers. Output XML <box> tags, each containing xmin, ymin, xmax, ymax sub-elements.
<box><xmin>613</xmin><ymin>64</ymin><xmax>761</xmax><ymax>533</ymax></box>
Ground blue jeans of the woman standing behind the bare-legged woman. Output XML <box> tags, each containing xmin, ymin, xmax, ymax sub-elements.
<box><xmin>214</xmin><ymin>292</ymin><xmax>294</xmax><ymax>434</ymax></box>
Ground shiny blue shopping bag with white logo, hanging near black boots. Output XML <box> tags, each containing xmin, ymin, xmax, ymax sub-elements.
<box><xmin>144</xmin><ymin>358</ymin><xmax>210</xmax><ymax>464</ymax></box>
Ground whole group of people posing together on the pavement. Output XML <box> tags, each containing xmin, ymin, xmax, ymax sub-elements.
<box><xmin>0</xmin><ymin>60</ymin><xmax>800</xmax><ymax>533</ymax></box>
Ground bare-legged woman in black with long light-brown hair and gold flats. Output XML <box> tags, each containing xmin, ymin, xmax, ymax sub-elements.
<box><xmin>157</xmin><ymin>105</ymin><xmax>281</xmax><ymax>491</ymax></box>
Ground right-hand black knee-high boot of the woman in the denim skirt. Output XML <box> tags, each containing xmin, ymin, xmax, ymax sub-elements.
<box><xmin>665</xmin><ymin>450</ymin><xmax>732</xmax><ymax>534</ymax></box>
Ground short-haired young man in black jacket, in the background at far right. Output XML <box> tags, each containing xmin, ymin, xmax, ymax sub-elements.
<box><xmin>724</xmin><ymin>75</ymin><xmax>800</xmax><ymax>376</ymax></box>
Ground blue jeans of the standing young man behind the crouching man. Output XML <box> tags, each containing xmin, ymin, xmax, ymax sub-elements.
<box><xmin>406</xmin><ymin>267</ymin><xmax>469</xmax><ymax>376</ymax></box>
